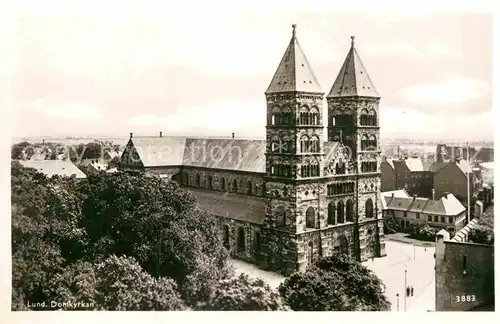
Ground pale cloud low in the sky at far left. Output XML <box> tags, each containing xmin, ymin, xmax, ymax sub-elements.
<box><xmin>31</xmin><ymin>99</ymin><xmax>101</xmax><ymax>121</ymax></box>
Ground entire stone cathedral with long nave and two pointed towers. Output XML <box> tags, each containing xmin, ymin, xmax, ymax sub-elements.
<box><xmin>120</xmin><ymin>25</ymin><xmax>386</xmax><ymax>275</ymax></box>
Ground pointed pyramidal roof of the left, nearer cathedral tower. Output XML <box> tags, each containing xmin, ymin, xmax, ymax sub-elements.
<box><xmin>266</xmin><ymin>25</ymin><xmax>324</xmax><ymax>94</ymax></box>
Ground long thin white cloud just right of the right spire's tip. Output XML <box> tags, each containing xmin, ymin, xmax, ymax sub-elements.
<box><xmin>364</xmin><ymin>40</ymin><xmax>463</xmax><ymax>58</ymax></box>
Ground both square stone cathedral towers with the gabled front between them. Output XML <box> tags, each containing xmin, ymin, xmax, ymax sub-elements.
<box><xmin>262</xmin><ymin>25</ymin><xmax>385</xmax><ymax>273</ymax></box>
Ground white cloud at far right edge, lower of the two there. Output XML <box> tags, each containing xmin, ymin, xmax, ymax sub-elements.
<box><xmin>400</xmin><ymin>77</ymin><xmax>490</xmax><ymax>103</ymax></box>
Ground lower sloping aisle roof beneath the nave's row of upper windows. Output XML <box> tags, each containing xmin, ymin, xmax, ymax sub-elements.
<box><xmin>189</xmin><ymin>188</ymin><xmax>266</xmax><ymax>225</ymax></box>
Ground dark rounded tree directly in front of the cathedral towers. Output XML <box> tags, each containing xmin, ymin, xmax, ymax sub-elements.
<box><xmin>279</xmin><ymin>254</ymin><xmax>390</xmax><ymax>311</ymax></box>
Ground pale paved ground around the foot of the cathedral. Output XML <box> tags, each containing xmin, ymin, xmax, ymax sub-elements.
<box><xmin>231</xmin><ymin>241</ymin><xmax>435</xmax><ymax>312</ymax></box>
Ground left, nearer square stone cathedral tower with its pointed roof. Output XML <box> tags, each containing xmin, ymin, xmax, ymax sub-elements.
<box><xmin>262</xmin><ymin>25</ymin><xmax>324</xmax><ymax>273</ymax></box>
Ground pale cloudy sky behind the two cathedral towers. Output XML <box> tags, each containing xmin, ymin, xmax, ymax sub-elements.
<box><xmin>0</xmin><ymin>1</ymin><xmax>493</xmax><ymax>139</ymax></box>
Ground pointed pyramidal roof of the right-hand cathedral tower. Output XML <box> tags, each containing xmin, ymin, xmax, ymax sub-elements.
<box><xmin>327</xmin><ymin>36</ymin><xmax>380</xmax><ymax>98</ymax></box>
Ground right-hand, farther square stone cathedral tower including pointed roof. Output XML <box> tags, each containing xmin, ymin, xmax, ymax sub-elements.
<box><xmin>327</xmin><ymin>36</ymin><xmax>385</xmax><ymax>260</ymax></box>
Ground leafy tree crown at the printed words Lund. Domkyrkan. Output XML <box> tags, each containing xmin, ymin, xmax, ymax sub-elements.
<box><xmin>47</xmin><ymin>255</ymin><xmax>184</xmax><ymax>311</ymax></box>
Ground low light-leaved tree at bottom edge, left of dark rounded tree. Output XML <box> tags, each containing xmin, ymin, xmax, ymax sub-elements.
<box><xmin>203</xmin><ymin>274</ymin><xmax>286</xmax><ymax>311</ymax></box>
